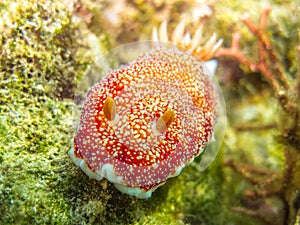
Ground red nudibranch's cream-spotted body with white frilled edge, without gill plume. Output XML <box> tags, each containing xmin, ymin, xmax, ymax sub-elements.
<box><xmin>69</xmin><ymin>46</ymin><xmax>218</xmax><ymax>198</ymax></box>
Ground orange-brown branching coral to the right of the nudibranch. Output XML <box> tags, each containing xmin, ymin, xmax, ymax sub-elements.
<box><xmin>216</xmin><ymin>4</ymin><xmax>300</xmax><ymax>224</ymax></box>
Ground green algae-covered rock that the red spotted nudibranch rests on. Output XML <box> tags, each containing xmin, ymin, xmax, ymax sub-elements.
<box><xmin>0</xmin><ymin>0</ymin><xmax>222</xmax><ymax>224</ymax></box>
